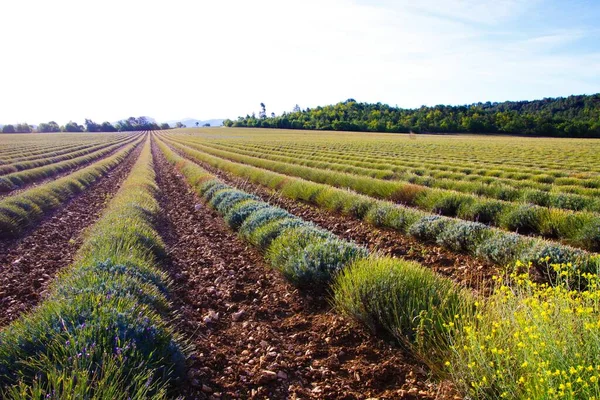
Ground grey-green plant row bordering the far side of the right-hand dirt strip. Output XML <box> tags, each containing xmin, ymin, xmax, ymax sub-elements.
<box><xmin>157</xmin><ymin>134</ymin><xmax>595</xmax><ymax>269</ymax></box>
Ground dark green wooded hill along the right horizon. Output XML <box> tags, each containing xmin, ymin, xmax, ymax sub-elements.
<box><xmin>223</xmin><ymin>94</ymin><xmax>600</xmax><ymax>137</ymax></box>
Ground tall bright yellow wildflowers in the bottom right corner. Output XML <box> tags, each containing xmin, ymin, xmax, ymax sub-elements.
<box><xmin>446</xmin><ymin>263</ymin><xmax>600</xmax><ymax>399</ymax></box>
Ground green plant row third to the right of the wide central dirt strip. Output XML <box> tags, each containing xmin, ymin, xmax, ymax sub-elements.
<box><xmin>168</xmin><ymin>136</ymin><xmax>600</xmax><ymax>251</ymax></box>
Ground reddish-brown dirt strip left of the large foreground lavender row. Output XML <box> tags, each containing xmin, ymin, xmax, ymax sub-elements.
<box><xmin>0</xmin><ymin>144</ymin><xmax>142</xmax><ymax>327</ymax></box>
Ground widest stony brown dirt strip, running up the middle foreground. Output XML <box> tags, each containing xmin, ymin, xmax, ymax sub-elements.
<box><xmin>153</xmin><ymin>140</ymin><xmax>451</xmax><ymax>399</ymax></box>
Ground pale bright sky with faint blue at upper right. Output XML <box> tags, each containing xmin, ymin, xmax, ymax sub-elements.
<box><xmin>0</xmin><ymin>0</ymin><xmax>600</xmax><ymax>124</ymax></box>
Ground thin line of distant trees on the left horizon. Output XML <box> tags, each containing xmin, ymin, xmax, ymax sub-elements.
<box><xmin>2</xmin><ymin>117</ymin><xmax>176</xmax><ymax>133</ymax></box>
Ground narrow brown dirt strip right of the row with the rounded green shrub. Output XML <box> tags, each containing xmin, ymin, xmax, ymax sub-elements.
<box><xmin>164</xmin><ymin>142</ymin><xmax>499</xmax><ymax>292</ymax></box>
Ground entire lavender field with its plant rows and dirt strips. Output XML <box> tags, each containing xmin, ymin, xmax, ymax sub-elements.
<box><xmin>0</xmin><ymin>128</ymin><xmax>600</xmax><ymax>399</ymax></box>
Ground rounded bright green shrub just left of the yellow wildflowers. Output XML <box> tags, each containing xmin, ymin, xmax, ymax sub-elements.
<box><xmin>332</xmin><ymin>257</ymin><xmax>472</xmax><ymax>367</ymax></box>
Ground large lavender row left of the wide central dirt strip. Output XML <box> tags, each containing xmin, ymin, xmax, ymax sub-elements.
<box><xmin>0</xmin><ymin>137</ymin><xmax>185</xmax><ymax>400</ymax></box>
